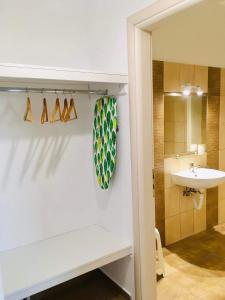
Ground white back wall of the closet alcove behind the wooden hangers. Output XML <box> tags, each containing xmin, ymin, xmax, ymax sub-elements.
<box><xmin>0</xmin><ymin>82</ymin><xmax>97</xmax><ymax>250</ymax></box>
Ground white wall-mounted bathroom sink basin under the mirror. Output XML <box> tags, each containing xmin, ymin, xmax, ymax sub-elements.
<box><xmin>172</xmin><ymin>168</ymin><xmax>225</xmax><ymax>189</ymax></box>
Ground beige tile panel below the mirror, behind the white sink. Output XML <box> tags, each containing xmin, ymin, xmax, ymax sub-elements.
<box><xmin>164</xmin><ymin>154</ymin><xmax>206</xmax><ymax>245</ymax></box>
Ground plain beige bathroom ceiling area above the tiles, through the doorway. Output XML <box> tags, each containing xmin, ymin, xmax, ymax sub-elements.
<box><xmin>152</xmin><ymin>0</ymin><xmax>225</xmax><ymax>67</ymax></box>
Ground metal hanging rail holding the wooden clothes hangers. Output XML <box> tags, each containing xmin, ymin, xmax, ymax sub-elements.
<box><xmin>0</xmin><ymin>87</ymin><xmax>108</xmax><ymax>96</ymax></box>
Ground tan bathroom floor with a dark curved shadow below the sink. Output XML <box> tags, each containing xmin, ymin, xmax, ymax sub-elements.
<box><xmin>157</xmin><ymin>225</ymin><xmax>225</xmax><ymax>300</ymax></box>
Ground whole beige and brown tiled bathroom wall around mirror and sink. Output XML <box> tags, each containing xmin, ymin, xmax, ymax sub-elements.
<box><xmin>153</xmin><ymin>62</ymin><xmax>222</xmax><ymax>244</ymax></box>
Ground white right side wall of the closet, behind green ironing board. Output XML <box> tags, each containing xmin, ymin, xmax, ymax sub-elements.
<box><xmin>90</xmin><ymin>85</ymin><xmax>134</xmax><ymax>299</ymax></box>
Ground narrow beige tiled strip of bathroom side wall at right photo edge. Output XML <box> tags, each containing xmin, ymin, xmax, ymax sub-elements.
<box><xmin>218</xmin><ymin>69</ymin><xmax>225</xmax><ymax>224</ymax></box>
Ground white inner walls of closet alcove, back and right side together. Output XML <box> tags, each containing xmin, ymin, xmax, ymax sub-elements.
<box><xmin>0</xmin><ymin>84</ymin><xmax>133</xmax><ymax>293</ymax></box>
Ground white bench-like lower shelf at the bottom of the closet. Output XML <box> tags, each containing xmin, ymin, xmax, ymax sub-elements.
<box><xmin>0</xmin><ymin>225</ymin><xmax>132</xmax><ymax>300</ymax></box>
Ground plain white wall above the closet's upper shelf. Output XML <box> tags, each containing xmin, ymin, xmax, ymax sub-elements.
<box><xmin>0</xmin><ymin>0</ymin><xmax>153</xmax><ymax>73</ymax></box>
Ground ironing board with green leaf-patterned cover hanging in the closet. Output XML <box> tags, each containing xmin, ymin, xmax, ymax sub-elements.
<box><xmin>93</xmin><ymin>96</ymin><xmax>117</xmax><ymax>190</ymax></box>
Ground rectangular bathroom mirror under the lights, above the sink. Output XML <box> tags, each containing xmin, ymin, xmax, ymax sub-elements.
<box><xmin>164</xmin><ymin>94</ymin><xmax>207</xmax><ymax>155</ymax></box>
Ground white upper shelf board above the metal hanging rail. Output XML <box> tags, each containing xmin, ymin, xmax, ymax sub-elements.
<box><xmin>0</xmin><ymin>63</ymin><xmax>128</xmax><ymax>84</ymax></box>
